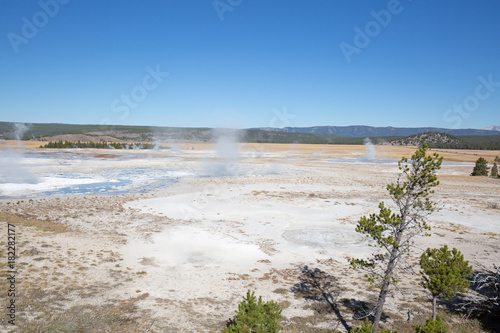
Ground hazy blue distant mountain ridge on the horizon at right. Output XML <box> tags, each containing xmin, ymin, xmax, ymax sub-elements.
<box><xmin>258</xmin><ymin>126</ymin><xmax>500</xmax><ymax>138</ymax></box>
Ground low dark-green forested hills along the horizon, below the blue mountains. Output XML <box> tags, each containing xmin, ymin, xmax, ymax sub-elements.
<box><xmin>0</xmin><ymin>122</ymin><xmax>500</xmax><ymax>150</ymax></box>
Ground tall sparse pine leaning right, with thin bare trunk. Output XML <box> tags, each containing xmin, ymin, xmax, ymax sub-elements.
<box><xmin>350</xmin><ymin>142</ymin><xmax>443</xmax><ymax>332</ymax></box>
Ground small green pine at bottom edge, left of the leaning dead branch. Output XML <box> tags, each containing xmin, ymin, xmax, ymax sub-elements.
<box><xmin>223</xmin><ymin>290</ymin><xmax>281</xmax><ymax>333</ymax></box>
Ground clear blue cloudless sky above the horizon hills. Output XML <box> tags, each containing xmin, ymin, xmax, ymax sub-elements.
<box><xmin>0</xmin><ymin>0</ymin><xmax>500</xmax><ymax>128</ymax></box>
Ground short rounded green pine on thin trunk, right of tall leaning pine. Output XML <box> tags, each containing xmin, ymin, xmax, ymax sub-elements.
<box><xmin>420</xmin><ymin>245</ymin><xmax>472</xmax><ymax>320</ymax></box>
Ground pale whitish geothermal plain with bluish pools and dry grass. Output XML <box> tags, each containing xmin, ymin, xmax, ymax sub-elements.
<box><xmin>0</xmin><ymin>142</ymin><xmax>500</xmax><ymax>332</ymax></box>
